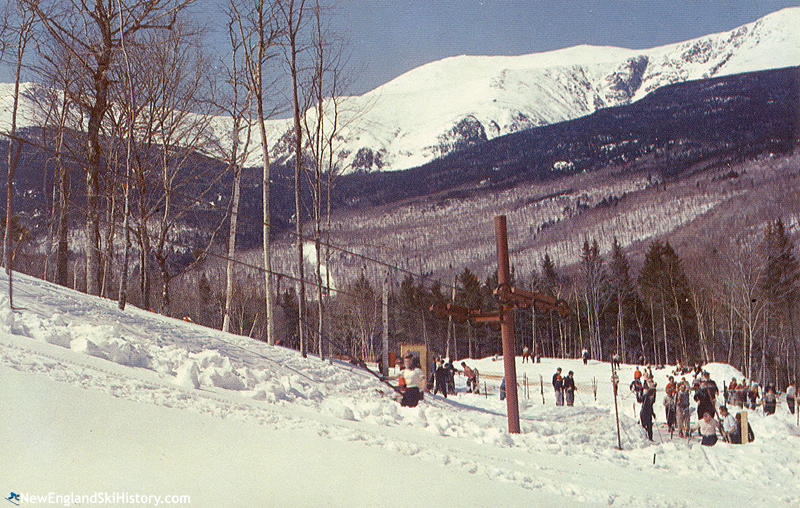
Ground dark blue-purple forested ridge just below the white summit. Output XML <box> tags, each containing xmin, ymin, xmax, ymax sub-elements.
<box><xmin>326</xmin><ymin>67</ymin><xmax>800</xmax><ymax>208</ymax></box>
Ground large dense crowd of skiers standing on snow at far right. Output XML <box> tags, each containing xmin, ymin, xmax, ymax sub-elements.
<box><xmin>630</xmin><ymin>366</ymin><xmax>764</xmax><ymax>446</ymax></box>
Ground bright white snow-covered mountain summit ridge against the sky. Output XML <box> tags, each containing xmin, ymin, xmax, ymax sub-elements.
<box><xmin>0</xmin><ymin>7</ymin><xmax>800</xmax><ymax>172</ymax></box>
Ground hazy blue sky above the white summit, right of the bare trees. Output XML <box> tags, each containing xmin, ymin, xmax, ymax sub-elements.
<box><xmin>336</xmin><ymin>0</ymin><xmax>800</xmax><ymax>93</ymax></box>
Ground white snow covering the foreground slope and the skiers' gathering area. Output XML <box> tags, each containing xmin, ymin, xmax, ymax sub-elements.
<box><xmin>0</xmin><ymin>274</ymin><xmax>800</xmax><ymax>508</ymax></box>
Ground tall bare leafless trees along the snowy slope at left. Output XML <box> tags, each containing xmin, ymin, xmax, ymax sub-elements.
<box><xmin>0</xmin><ymin>0</ymin><xmax>346</xmax><ymax>362</ymax></box>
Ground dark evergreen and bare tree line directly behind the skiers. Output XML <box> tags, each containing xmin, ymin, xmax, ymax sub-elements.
<box><xmin>310</xmin><ymin>219</ymin><xmax>800</xmax><ymax>386</ymax></box>
